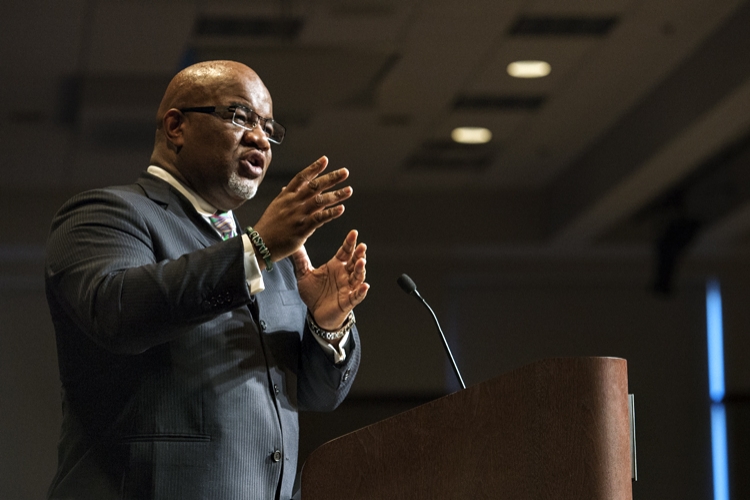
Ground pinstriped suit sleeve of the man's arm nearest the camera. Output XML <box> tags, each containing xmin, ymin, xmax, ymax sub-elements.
<box><xmin>45</xmin><ymin>190</ymin><xmax>250</xmax><ymax>353</ymax></box>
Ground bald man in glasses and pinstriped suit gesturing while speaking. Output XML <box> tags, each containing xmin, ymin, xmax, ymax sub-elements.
<box><xmin>46</xmin><ymin>61</ymin><xmax>368</xmax><ymax>500</ymax></box>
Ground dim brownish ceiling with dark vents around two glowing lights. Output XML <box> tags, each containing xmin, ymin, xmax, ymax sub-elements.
<box><xmin>0</xmin><ymin>0</ymin><xmax>750</xmax><ymax>288</ymax></box>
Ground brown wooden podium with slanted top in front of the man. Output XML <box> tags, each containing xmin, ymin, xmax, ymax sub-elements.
<box><xmin>301</xmin><ymin>358</ymin><xmax>632</xmax><ymax>500</ymax></box>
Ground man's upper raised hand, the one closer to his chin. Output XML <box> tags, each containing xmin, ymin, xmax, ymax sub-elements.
<box><xmin>253</xmin><ymin>156</ymin><xmax>352</xmax><ymax>262</ymax></box>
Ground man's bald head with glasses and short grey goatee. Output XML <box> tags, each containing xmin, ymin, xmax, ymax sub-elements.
<box><xmin>151</xmin><ymin>61</ymin><xmax>273</xmax><ymax>210</ymax></box>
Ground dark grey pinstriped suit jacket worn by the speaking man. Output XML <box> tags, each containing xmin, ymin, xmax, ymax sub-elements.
<box><xmin>46</xmin><ymin>174</ymin><xmax>360</xmax><ymax>500</ymax></box>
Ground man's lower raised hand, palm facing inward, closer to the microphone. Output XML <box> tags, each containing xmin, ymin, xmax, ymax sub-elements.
<box><xmin>292</xmin><ymin>230</ymin><xmax>370</xmax><ymax>331</ymax></box>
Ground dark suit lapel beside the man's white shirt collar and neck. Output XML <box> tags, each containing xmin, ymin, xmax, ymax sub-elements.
<box><xmin>136</xmin><ymin>172</ymin><xmax>221</xmax><ymax>247</ymax></box>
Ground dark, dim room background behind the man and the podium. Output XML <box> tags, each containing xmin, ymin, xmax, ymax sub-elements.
<box><xmin>0</xmin><ymin>0</ymin><xmax>750</xmax><ymax>500</ymax></box>
